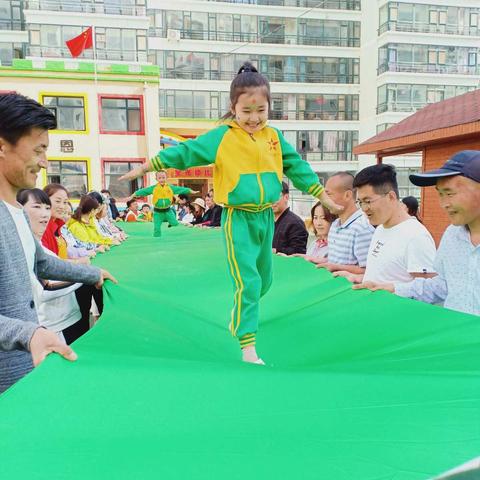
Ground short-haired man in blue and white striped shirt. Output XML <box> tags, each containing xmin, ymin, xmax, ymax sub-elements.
<box><xmin>309</xmin><ymin>172</ymin><xmax>375</xmax><ymax>274</ymax></box>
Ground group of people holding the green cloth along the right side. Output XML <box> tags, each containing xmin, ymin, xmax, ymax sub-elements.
<box><xmin>273</xmin><ymin>156</ymin><xmax>480</xmax><ymax>322</ymax></box>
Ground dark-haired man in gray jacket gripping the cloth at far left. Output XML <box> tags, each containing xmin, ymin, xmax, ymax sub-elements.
<box><xmin>0</xmin><ymin>93</ymin><xmax>116</xmax><ymax>392</ymax></box>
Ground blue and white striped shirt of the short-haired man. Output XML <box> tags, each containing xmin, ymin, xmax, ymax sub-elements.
<box><xmin>328</xmin><ymin>210</ymin><xmax>375</xmax><ymax>267</ymax></box>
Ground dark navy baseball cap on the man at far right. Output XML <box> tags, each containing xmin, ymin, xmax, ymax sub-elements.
<box><xmin>409</xmin><ymin>150</ymin><xmax>480</xmax><ymax>187</ymax></box>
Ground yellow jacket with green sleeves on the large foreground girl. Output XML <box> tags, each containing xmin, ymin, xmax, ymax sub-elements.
<box><xmin>150</xmin><ymin>122</ymin><xmax>323</xmax><ymax>211</ymax></box>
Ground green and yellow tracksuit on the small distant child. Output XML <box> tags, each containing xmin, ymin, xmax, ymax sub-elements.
<box><xmin>134</xmin><ymin>183</ymin><xmax>192</xmax><ymax>237</ymax></box>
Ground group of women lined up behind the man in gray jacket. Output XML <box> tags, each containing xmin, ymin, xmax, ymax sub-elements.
<box><xmin>17</xmin><ymin>183</ymin><xmax>127</xmax><ymax>345</ymax></box>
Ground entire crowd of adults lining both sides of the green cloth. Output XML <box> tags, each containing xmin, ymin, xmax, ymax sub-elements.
<box><xmin>0</xmin><ymin>94</ymin><xmax>480</xmax><ymax>392</ymax></box>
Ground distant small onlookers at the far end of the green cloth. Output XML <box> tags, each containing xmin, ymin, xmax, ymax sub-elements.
<box><xmin>118</xmin><ymin>190</ymin><xmax>223</xmax><ymax>227</ymax></box>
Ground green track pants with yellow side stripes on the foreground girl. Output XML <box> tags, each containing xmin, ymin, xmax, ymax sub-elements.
<box><xmin>222</xmin><ymin>208</ymin><xmax>274</xmax><ymax>348</ymax></box>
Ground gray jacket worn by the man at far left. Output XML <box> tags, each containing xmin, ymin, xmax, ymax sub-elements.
<box><xmin>0</xmin><ymin>200</ymin><xmax>100</xmax><ymax>392</ymax></box>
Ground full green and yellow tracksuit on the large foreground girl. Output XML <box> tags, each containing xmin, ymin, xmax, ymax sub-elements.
<box><xmin>150</xmin><ymin>121</ymin><xmax>323</xmax><ymax>348</ymax></box>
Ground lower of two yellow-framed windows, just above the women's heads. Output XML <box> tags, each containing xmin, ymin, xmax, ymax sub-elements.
<box><xmin>47</xmin><ymin>160</ymin><xmax>89</xmax><ymax>199</ymax></box>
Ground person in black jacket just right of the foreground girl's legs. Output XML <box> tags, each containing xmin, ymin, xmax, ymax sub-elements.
<box><xmin>272</xmin><ymin>182</ymin><xmax>308</xmax><ymax>255</ymax></box>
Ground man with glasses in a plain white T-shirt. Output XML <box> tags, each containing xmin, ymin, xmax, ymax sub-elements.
<box><xmin>337</xmin><ymin>164</ymin><xmax>435</xmax><ymax>283</ymax></box>
